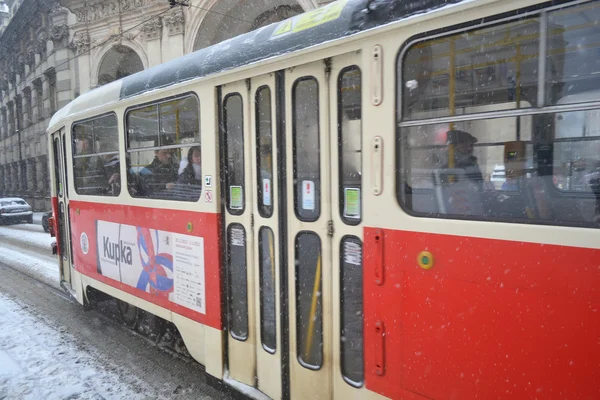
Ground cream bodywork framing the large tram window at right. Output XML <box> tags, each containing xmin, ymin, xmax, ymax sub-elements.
<box><xmin>356</xmin><ymin>1</ymin><xmax>600</xmax><ymax>248</ymax></box>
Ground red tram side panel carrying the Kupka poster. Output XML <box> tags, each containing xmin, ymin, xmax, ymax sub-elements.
<box><xmin>71</xmin><ymin>201</ymin><xmax>222</xmax><ymax>354</ymax></box>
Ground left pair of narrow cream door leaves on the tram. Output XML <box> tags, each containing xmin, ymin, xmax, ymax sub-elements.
<box><xmin>221</xmin><ymin>74</ymin><xmax>282</xmax><ymax>399</ymax></box>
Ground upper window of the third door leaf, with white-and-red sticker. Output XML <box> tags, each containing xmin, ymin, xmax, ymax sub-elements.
<box><xmin>292</xmin><ymin>77</ymin><xmax>321</xmax><ymax>222</ymax></box>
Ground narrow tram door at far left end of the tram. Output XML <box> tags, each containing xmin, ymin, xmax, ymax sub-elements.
<box><xmin>52</xmin><ymin>130</ymin><xmax>74</xmax><ymax>289</ymax></box>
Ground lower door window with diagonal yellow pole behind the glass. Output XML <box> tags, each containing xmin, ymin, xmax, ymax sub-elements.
<box><xmin>295</xmin><ymin>232</ymin><xmax>323</xmax><ymax>370</ymax></box>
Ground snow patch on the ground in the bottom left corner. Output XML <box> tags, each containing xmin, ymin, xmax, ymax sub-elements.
<box><xmin>0</xmin><ymin>294</ymin><xmax>153</xmax><ymax>400</ymax></box>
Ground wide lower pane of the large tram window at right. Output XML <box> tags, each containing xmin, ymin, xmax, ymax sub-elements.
<box><xmin>398</xmin><ymin>110</ymin><xmax>600</xmax><ymax>227</ymax></box>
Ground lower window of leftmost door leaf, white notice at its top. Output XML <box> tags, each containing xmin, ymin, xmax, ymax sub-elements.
<box><xmin>227</xmin><ymin>224</ymin><xmax>248</xmax><ymax>341</ymax></box>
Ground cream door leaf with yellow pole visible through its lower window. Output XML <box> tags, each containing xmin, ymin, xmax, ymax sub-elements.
<box><xmin>285</xmin><ymin>62</ymin><xmax>333</xmax><ymax>399</ymax></box>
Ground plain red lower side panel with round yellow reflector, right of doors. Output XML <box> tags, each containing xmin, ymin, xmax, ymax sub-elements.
<box><xmin>365</xmin><ymin>228</ymin><xmax>600</xmax><ymax>398</ymax></box>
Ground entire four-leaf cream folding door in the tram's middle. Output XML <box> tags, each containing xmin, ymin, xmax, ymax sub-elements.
<box><xmin>221</xmin><ymin>54</ymin><xmax>363</xmax><ymax>399</ymax></box>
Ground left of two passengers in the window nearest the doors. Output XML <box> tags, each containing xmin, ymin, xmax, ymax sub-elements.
<box><xmin>140</xmin><ymin>140</ymin><xmax>178</xmax><ymax>197</ymax></box>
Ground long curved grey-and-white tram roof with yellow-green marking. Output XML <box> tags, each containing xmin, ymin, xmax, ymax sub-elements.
<box><xmin>50</xmin><ymin>0</ymin><xmax>469</xmax><ymax>127</ymax></box>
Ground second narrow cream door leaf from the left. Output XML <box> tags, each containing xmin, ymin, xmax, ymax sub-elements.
<box><xmin>249</xmin><ymin>74</ymin><xmax>283</xmax><ymax>399</ymax></box>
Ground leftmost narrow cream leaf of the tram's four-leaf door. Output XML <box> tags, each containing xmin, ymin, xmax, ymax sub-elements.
<box><xmin>221</xmin><ymin>81</ymin><xmax>257</xmax><ymax>386</ymax></box>
